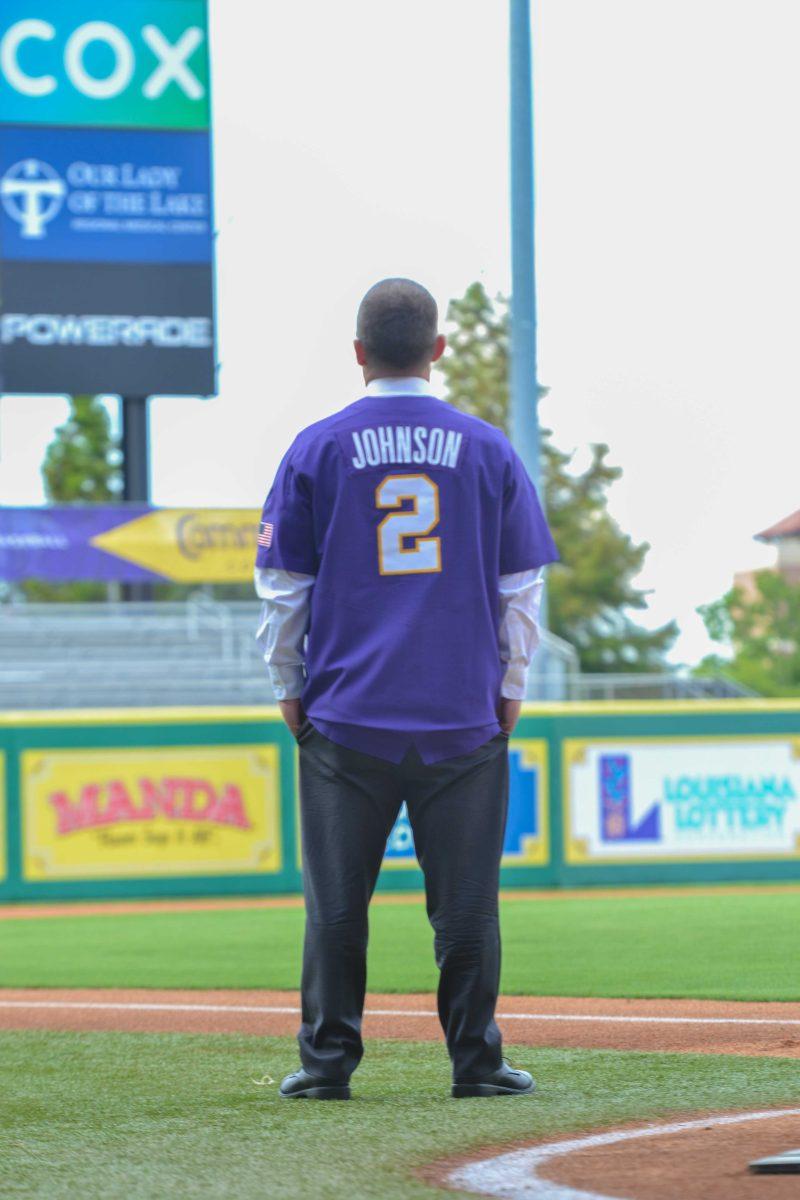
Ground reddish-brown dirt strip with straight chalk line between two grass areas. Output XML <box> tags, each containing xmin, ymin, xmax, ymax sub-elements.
<box><xmin>0</xmin><ymin>989</ymin><xmax>800</xmax><ymax>1056</ymax></box>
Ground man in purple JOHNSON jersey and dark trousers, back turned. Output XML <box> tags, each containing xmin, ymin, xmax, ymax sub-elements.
<box><xmin>255</xmin><ymin>280</ymin><xmax>558</xmax><ymax>1099</ymax></box>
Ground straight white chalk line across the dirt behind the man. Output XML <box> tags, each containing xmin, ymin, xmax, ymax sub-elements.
<box><xmin>0</xmin><ymin>1000</ymin><xmax>800</xmax><ymax>1026</ymax></box>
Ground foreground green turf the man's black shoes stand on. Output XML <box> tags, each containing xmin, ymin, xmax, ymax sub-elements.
<box><xmin>0</xmin><ymin>1033</ymin><xmax>799</xmax><ymax>1200</ymax></box>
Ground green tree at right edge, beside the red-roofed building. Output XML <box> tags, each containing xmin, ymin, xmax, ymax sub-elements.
<box><xmin>697</xmin><ymin>571</ymin><xmax>800</xmax><ymax>696</ymax></box>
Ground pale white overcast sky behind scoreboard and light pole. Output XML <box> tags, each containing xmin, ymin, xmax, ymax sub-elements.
<box><xmin>0</xmin><ymin>0</ymin><xmax>800</xmax><ymax>661</ymax></box>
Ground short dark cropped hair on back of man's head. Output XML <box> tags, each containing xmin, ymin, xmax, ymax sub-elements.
<box><xmin>356</xmin><ymin>280</ymin><xmax>439</xmax><ymax>371</ymax></box>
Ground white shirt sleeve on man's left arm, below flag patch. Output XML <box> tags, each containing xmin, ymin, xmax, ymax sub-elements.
<box><xmin>255</xmin><ymin>566</ymin><xmax>315</xmax><ymax>700</ymax></box>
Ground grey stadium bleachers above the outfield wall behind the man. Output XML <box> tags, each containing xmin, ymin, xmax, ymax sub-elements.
<box><xmin>0</xmin><ymin>596</ymin><xmax>745</xmax><ymax>709</ymax></box>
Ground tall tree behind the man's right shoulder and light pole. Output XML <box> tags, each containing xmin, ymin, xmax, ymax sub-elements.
<box><xmin>439</xmin><ymin>283</ymin><xmax>678</xmax><ymax>672</ymax></box>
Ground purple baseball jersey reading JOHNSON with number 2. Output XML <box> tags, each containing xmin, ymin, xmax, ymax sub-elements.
<box><xmin>257</xmin><ymin>395</ymin><xmax>558</xmax><ymax>737</ymax></box>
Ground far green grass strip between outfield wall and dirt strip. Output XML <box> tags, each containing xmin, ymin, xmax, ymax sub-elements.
<box><xmin>0</xmin><ymin>889</ymin><xmax>800</xmax><ymax>1000</ymax></box>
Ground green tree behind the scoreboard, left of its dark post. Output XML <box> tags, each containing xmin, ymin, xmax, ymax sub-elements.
<box><xmin>23</xmin><ymin>396</ymin><xmax>122</xmax><ymax>601</ymax></box>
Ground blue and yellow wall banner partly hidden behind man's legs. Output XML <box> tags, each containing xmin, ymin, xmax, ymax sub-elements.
<box><xmin>384</xmin><ymin>738</ymin><xmax>551</xmax><ymax>869</ymax></box>
